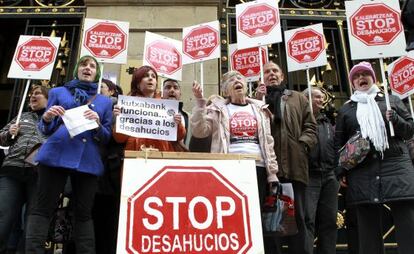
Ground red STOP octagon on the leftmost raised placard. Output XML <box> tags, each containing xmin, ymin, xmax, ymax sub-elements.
<box><xmin>15</xmin><ymin>38</ymin><xmax>58</xmax><ymax>71</ymax></box>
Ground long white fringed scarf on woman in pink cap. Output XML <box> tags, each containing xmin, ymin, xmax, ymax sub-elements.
<box><xmin>351</xmin><ymin>85</ymin><xmax>389</xmax><ymax>156</ymax></box>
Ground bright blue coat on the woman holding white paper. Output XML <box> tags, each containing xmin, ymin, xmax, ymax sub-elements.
<box><xmin>36</xmin><ymin>87</ymin><xmax>112</xmax><ymax>175</ymax></box>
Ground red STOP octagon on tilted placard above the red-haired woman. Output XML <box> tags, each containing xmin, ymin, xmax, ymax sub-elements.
<box><xmin>145</xmin><ymin>40</ymin><xmax>182</xmax><ymax>75</ymax></box>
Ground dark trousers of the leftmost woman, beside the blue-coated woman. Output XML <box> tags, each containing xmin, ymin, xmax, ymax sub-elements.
<box><xmin>0</xmin><ymin>174</ymin><xmax>36</xmax><ymax>253</ymax></box>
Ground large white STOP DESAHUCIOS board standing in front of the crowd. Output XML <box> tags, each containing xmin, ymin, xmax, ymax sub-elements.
<box><xmin>117</xmin><ymin>158</ymin><xmax>264</xmax><ymax>254</ymax></box>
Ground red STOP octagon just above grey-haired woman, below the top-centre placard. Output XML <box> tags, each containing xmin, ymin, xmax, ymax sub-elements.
<box><xmin>231</xmin><ymin>47</ymin><xmax>267</xmax><ymax>78</ymax></box>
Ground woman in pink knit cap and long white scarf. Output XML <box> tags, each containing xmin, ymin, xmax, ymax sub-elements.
<box><xmin>334</xmin><ymin>62</ymin><xmax>414</xmax><ymax>254</ymax></box>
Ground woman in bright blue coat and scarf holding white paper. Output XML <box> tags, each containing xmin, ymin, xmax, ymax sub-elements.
<box><xmin>26</xmin><ymin>56</ymin><xmax>112</xmax><ymax>254</ymax></box>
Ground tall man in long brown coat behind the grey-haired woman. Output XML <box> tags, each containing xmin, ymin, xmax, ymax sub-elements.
<box><xmin>256</xmin><ymin>62</ymin><xmax>316</xmax><ymax>254</ymax></box>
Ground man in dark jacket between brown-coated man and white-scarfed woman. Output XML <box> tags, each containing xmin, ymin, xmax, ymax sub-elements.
<box><xmin>303</xmin><ymin>88</ymin><xmax>339</xmax><ymax>254</ymax></box>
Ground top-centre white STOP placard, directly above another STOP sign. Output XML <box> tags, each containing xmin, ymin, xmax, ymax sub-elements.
<box><xmin>236</xmin><ymin>0</ymin><xmax>282</xmax><ymax>49</ymax></box>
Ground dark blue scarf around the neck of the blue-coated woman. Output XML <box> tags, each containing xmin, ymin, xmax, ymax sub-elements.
<box><xmin>64</xmin><ymin>79</ymin><xmax>98</xmax><ymax>106</ymax></box>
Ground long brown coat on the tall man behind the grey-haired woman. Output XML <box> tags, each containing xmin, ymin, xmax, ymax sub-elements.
<box><xmin>272</xmin><ymin>89</ymin><xmax>317</xmax><ymax>184</ymax></box>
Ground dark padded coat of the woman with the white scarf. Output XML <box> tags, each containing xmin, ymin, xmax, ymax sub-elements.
<box><xmin>335</xmin><ymin>93</ymin><xmax>414</xmax><ymax>205</ymax></box>
